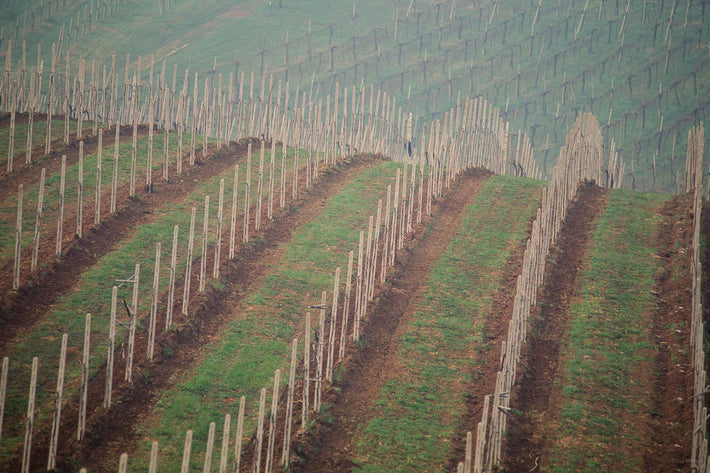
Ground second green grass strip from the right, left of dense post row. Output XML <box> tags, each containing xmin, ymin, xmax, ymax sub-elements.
<box><xmin>354</xmin><ymin>176</ymin><xmax>543</xmax><ymax>472</ymax></box>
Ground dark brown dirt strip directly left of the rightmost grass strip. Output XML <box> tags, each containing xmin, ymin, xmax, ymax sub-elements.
<box><xmin>503</xmin><ymin>185</ymin><xmax>607</xmax><ymax>473</ymax></box>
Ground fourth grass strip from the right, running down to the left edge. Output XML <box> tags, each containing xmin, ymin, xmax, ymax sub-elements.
<box><xmin>0</xmin><ymin>137</ymin><xmax>298</xmax><ymax>466</ymax></box>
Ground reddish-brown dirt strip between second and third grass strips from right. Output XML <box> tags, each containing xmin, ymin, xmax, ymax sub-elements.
<box><xmin>292</xmin><ymin>171</ymin><xmax>489</xmax><ymax>472</ymax></box>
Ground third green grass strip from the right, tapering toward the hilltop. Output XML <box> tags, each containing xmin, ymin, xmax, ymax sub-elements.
<box><xmin>132</xmin><ymin>162</ymin><xmax>404</xmax><ymax>471</ymax></box>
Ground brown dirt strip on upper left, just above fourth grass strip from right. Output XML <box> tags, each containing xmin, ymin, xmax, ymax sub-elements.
<box><xmin>0</xmin><ymin>144</ymin><xmax>246</xmax><ymax>351</ymax></box>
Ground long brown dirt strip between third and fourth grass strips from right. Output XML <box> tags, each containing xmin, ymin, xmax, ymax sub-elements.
<box><xmin>10</xmin><ymin>157</ymin><xmax>379</xmax><ymax>471</ymax></box>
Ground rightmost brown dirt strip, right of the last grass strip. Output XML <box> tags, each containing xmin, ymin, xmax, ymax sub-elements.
<box><xmin>644</xmin><ymin>195</ymin><xmax>693</xmax><ymax>473</ymax></box>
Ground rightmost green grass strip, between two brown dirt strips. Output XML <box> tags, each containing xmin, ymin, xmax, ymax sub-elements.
<box><xmin>549</xmin><ymin>191</ymin><xmax>669</xmax><ymax>472</ymax></box>
